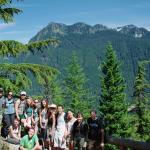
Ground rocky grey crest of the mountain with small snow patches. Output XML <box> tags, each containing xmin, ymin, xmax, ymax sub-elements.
<box><xmin>29</xmin><ymin>22</ymin><xmax>150</xmax><ymax>42</ymax></box>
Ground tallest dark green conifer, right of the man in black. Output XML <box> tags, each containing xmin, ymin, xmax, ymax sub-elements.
<box><xmin>100</xmin><ymin>44</ymin><xmax>129</xmax><ymax>136</ymax></box>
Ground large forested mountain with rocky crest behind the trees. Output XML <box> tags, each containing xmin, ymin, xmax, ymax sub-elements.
<box><xmin>21</xmin><ymin>22</ymin><xmax>150</xmax><ymax>96</ymax></box>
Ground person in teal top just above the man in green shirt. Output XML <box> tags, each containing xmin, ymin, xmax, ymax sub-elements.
<box><xmin>21</xmin><ymin>97</ymin><xmax>33</xmax><ymax>128</ymax></box>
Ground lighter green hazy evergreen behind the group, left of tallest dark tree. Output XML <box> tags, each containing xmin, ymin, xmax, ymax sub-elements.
<box><xmin>64</xmin><ymin>53</ymin><xmax>90</xmax><ymax>116</ymax></box>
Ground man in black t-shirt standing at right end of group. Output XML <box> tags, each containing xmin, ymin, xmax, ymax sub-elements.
<box><xmin>87</xmin><ymin>110</ymin><xmax>104</xmax><ymax>150</ymax></box>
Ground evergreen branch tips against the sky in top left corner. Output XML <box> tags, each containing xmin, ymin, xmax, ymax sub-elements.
<box><xmin>0</xmin><ymin>0</ymin><xmax>22</xmax><ymax>23</ymax></box>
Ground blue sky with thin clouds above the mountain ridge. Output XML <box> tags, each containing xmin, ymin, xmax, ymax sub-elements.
<box><xmin>0</xmin><ymin>0</ymin><xmax>150</xmax><ymax>43</ymax></box>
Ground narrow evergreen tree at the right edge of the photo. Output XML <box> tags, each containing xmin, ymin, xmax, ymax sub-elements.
<box><xmin>133</xmin><ymin>62</ymin><xmax>150</xmax><ymax>141</ymax></box>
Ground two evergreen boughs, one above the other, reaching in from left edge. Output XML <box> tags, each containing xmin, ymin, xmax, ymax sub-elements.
<box><xmin>0</xmin><ymin>39</ymin><xmax>58</xmax><ymax>92</ymax></box>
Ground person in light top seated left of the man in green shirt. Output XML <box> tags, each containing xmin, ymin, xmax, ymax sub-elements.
<box><xmin>7</xmin><ymin>118</ymin><xmax>21</xmax><ymax>144</ymax></box>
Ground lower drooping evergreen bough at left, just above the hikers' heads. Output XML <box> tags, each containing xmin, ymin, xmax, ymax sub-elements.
<box><xmin>0</xmin><ymin>63</ymin><xmax>58</xmax><ymax>92</ymax></box>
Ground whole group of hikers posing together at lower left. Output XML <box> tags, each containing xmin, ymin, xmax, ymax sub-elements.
<box><xmin>0</xmin><ymin>88</ymin><xmax>104</xmax><ymax>150</ymax></box>
